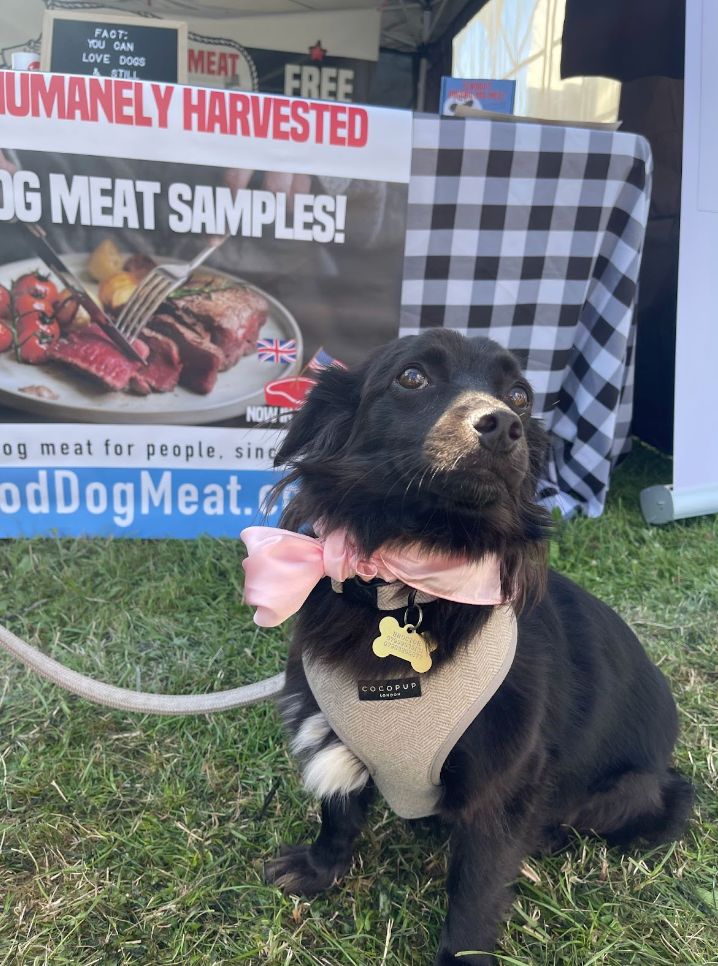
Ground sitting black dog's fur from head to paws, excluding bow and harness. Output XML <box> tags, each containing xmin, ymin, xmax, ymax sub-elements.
<box><xmin>258</xmin><ymin>330</ymin><xmax>693</xmax><ymax>964</ymax></box>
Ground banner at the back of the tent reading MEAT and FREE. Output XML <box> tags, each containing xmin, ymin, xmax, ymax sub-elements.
<box><xmin>0</xmin><ymin>0</ymin><xmax>381</xmax><ymax>101</ymax></box>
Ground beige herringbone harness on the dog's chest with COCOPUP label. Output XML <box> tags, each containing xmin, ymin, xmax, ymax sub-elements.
<box><xmin>304</xmin><ymin>597</ymin><xmax>517</xmax><ymax>818</ymax></box>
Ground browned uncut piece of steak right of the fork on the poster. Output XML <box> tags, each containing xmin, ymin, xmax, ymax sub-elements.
<box><xmin>163</xmin><ymin>285</ymin><xmax>269</xmax><ymax>369</ymax></box>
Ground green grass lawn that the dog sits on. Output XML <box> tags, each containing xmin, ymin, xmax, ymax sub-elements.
<box><xmin>0</xmin><ymin>447</ymin><xmax>718</xmax><ymax>966</ymax></box>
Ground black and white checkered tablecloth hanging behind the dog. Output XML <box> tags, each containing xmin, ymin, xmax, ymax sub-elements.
<box><xmin>401</xmin><ymin>115</ymin><xmax>651</xmax><ymax>516</ymax></box>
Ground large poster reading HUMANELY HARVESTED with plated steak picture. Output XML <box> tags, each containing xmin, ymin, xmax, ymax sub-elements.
<box><xmin>0</xmin><ymin>71</ymin><xmax>411</xmax><ymax>537</ymax></box>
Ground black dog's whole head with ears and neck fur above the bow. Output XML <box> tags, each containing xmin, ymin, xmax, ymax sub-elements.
<box><xmin>277</xmin><ymin>329</ymin><xmax>545</xmax><ymax>572</ymax></box>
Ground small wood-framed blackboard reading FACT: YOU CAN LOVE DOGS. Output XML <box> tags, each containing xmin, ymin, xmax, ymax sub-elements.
<box><xmin>41</xmin><ymin>10</ymin><xmax>187</xmax><ymax>83</ymax></box>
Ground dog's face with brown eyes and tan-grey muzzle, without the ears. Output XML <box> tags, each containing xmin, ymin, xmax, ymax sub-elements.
<box><xmin>376</xmin><ymin>330</ymin><xmax>531</xmax><ymax>511</ymax></box>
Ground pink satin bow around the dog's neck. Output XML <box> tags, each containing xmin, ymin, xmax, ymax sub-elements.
<box><xmin>240</xmin><ymin>527</ymin><xmax>504</xmax><ymax>627</ymax></box>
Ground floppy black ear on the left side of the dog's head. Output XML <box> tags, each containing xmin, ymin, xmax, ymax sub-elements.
<box><xmin>274</xmin><ymin>366</ymin><xmax>363</xmax><ymax>466</ymax></box>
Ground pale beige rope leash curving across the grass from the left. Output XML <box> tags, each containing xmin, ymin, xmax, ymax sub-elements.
<box><xmin>0</xmin><ymin>624</ymin><xmax>284</xmax><ymax>715</ymax></box>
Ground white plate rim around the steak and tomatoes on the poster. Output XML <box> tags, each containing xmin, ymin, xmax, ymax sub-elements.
<box><xmin>0</xmin><ymin>255</ymin><xmax>302</xmax><ymax>425</ymax></box>
